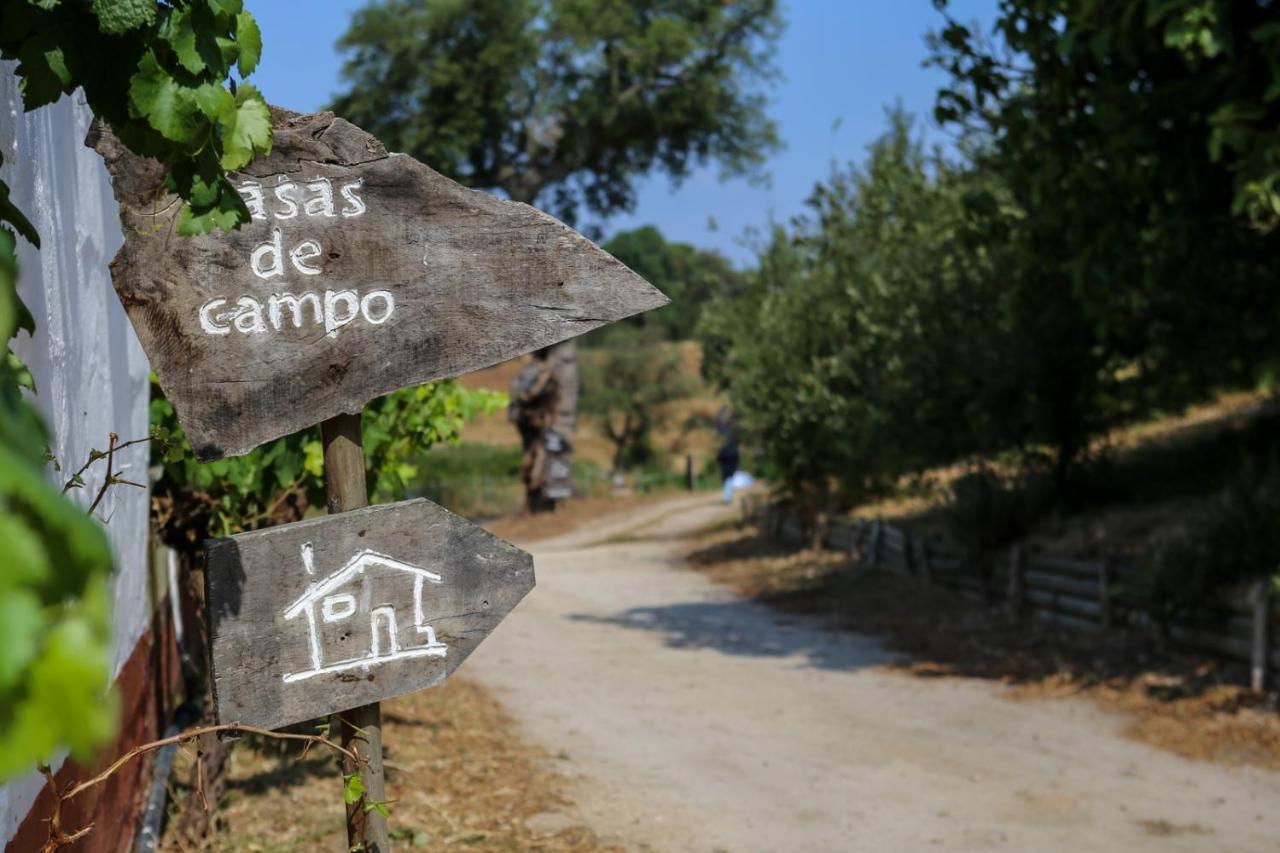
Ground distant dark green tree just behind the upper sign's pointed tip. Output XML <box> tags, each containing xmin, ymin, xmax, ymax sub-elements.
<box><xmin>584</xmin><ymin>225</ymin><xmax>742</xmax><ymax>346</ymax></box>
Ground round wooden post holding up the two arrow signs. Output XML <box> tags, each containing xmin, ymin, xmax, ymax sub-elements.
<box><xmin>320</xmin><ymin>415</ymin><xmax>392</xmax><ymax>853</ymax></box>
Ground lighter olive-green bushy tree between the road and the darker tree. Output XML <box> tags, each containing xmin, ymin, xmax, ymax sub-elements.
<box><xmin>699</xmin><ymin>111</ymin><xmax>1002</xmax><ymax>521</ymax></box>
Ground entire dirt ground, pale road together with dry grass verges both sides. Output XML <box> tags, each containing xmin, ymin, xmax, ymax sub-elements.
<box><xmin>172</xmin><ymin>494</ymin><xmax>1280</xmax><ymax>853</ymax></box>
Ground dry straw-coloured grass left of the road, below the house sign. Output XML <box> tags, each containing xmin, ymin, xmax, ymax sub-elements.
<box><xmin>169</xmin><ymin>678</ymin><xmax>617</xmax><ymax>853</ymax></box>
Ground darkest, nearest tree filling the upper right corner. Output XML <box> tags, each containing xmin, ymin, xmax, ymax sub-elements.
<box><xmin>934</xmin><ymin>0</ymin><xmax>1280</xmax><ymax>491</ymax></box>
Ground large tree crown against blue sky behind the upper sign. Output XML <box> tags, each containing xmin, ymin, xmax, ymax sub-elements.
<box><xmin>333</xmin><ymin>0</ymin><xmax>781</xmax><ymax>222</ymax></box>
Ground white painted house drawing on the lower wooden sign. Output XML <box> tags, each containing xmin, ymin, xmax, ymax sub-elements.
<box><xmin>284</xmin><ymin>543</ymin><xmax>448</xmax><ymax>683</ymax></box>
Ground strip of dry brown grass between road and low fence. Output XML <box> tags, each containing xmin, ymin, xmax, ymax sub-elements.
<box><xmin>690</xmin><ymin>529</ymin><xmax>1280</xmax><ymax>770</ymax></box>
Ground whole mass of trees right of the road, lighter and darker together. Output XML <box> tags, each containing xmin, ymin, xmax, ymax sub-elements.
<box><xmin>700</xmin><ymin>0</ymin><xmax>1280</xmax><ymax>532</ymax></box>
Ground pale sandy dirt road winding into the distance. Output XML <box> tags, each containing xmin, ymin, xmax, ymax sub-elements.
<box><xmin>467</xmin><ymin>497</ymin><xmax>1280</xmax><ymax>853</ymax></box>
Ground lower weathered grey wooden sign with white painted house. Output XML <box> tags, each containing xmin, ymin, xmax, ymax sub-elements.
<box><xmin>205</xmin><ymin>500</ymin><xmax>534</xmax><ymax>729</ymax></box>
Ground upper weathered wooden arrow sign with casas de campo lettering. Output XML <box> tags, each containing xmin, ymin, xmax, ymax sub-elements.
<box><xmin>90</xmin><ymin>110</ymin><xmax>667</xmax><ymax>461</ymax></box>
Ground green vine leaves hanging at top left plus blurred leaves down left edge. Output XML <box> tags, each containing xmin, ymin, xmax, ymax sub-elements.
<box><xmin>0</xmin><ymin>0</ymin><xmax>271</xmax><ymax>781</ymax></box>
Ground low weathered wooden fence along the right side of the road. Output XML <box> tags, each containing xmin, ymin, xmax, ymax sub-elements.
<box><xmin>748</xmin><ymin>506</ymin><xmax>1280</xmax><ymax>690</ymax></box>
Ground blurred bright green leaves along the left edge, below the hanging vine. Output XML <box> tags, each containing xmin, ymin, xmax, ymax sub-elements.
<box><xmin>0</xmin><ymin>229</ymin><xmax>115</xmax><ymax>780</ymax></box>
